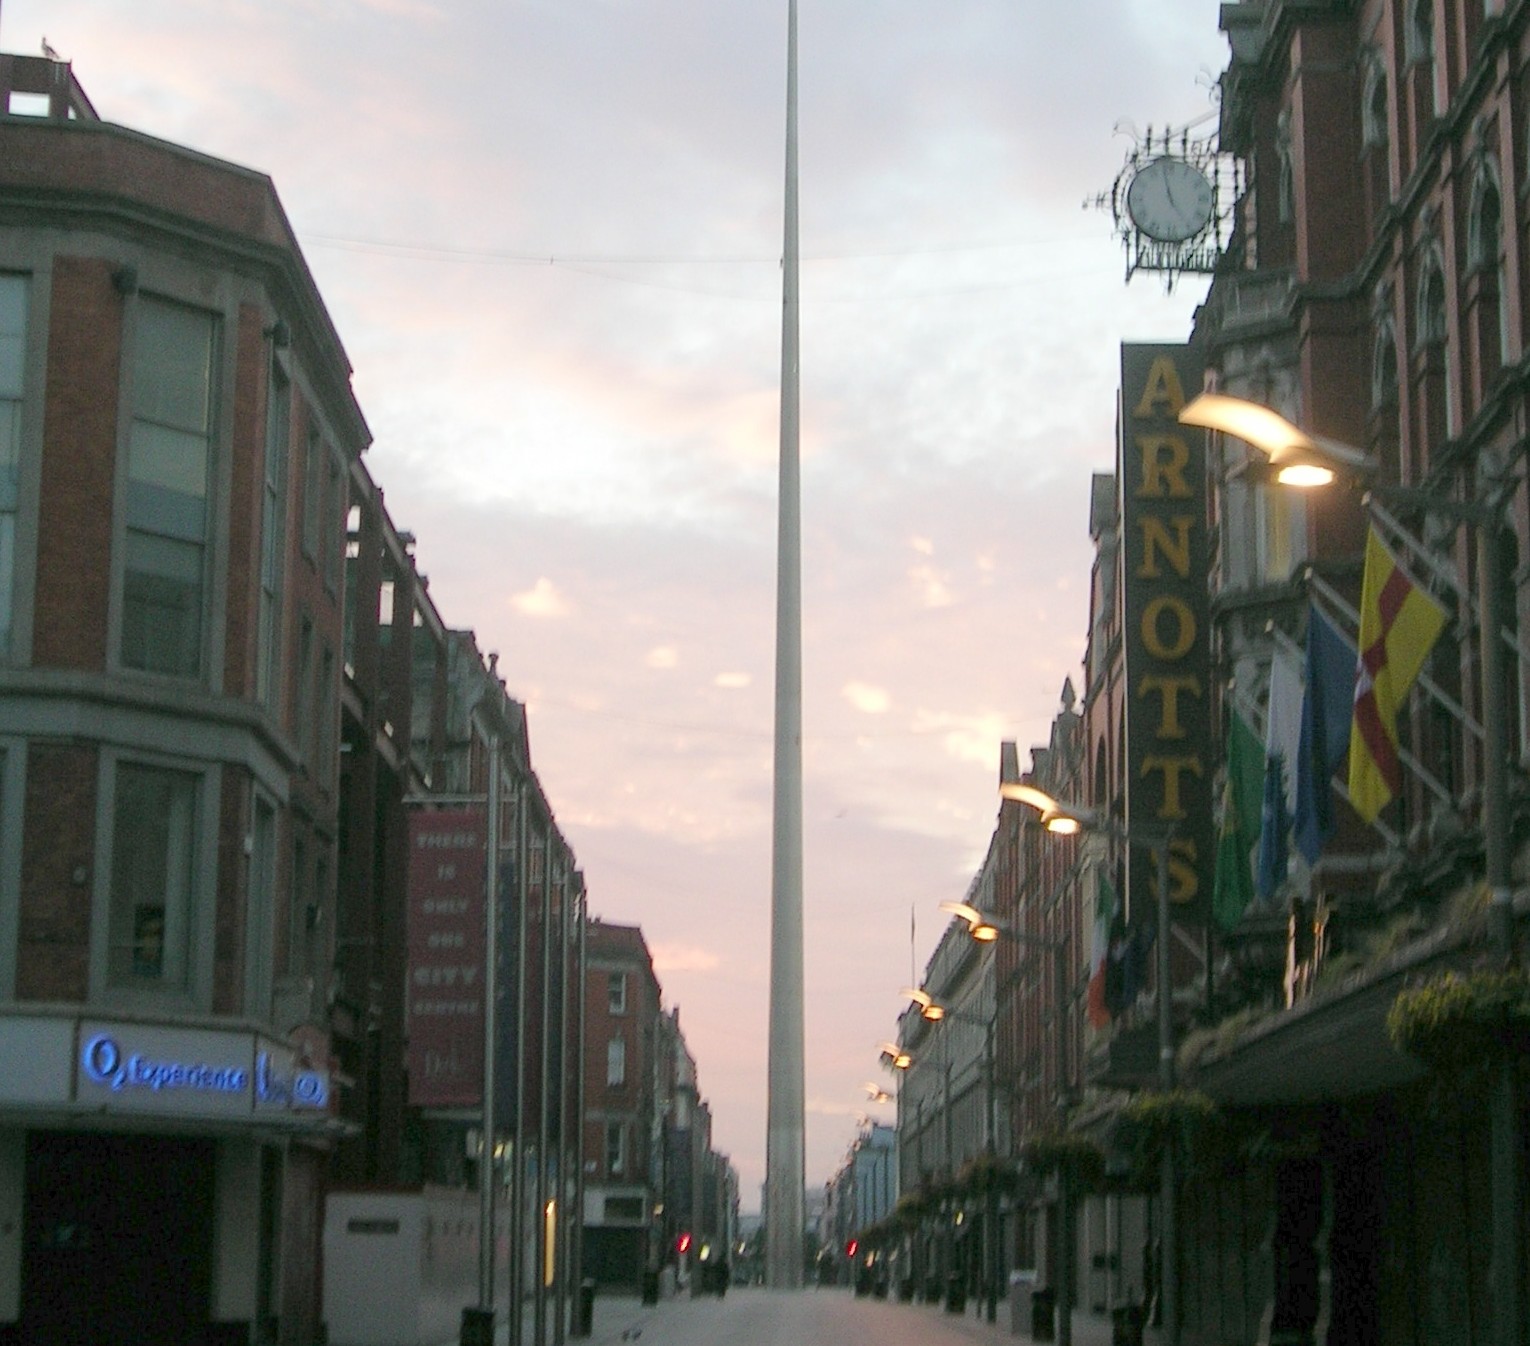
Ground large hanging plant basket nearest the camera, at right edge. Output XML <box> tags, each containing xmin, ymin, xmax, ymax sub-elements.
<box><xmin>1386</xmin><ymin>971</ymin><xmax>1530</xmax><ymax>1075</ymax></box>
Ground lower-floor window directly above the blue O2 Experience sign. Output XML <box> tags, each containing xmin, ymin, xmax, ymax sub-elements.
<box><xmin>107</xmin><ymin>762</ymin><xmax>199</xmax><ymax>990</ymax></box>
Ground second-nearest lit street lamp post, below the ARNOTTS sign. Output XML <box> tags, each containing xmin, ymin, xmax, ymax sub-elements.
<box><xmin>997</xmin><ymin>780</ymin><xmax>1180</xmax><ymax>1346</ymax></box>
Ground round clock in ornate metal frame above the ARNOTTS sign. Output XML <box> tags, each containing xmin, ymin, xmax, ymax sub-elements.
<box><xmin>1085</xmin><ymin>127</ymin><xmax>1238</xmax><ymax>289</ymax></box>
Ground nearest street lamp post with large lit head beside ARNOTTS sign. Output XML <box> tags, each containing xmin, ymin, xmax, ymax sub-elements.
<box><xmin>1180</xmin><ymin>393</ymin><xmax>1524</xmax><ymax>1346</ymax></box>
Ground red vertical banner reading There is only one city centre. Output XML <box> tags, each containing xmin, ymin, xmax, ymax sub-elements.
<box><xmin>405</xmin><ymin>809</ymin><xmax>487</xmax><ymax>1107</ymax></box>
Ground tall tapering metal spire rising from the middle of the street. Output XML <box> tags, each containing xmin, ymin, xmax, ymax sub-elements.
<box><xmin>765</xmin><ymin>0</ymin><xmax>805</xmax><ymax>1289</ymax></box>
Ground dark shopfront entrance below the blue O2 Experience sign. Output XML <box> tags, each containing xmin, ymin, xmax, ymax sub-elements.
<box><xmin>20</xmin><ymin>1132</ymin><xmax>214</xmax><ymax>1346</ymax></box>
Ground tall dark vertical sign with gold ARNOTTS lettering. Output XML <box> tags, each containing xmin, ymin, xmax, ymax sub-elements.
<box><xmin>1117</xmin><ymin>346</ymin><xmax>1216</xmax><ymax>919</ymax></box>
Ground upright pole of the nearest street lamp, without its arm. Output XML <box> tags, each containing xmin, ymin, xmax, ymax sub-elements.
<box><xmin>1476</xmin><ymin>507</ymin><xmax>1525</xmax><ymax>1346</ymax></box>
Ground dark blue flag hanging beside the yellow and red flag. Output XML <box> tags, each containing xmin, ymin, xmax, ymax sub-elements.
<box><xmin>1294</xmin><ymin>603</ymin><xmax>1354</xmax><ymax>864</ymax></box>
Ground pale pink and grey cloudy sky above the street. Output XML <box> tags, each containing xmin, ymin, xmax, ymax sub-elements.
<box><xmin>0</xmin><ymin>0</ymin><xmax>1226</xmax><ymax>1208</ymax></box>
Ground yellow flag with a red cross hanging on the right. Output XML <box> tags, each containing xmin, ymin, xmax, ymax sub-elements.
<box><xmin>1349</xmin><ymin>526</ymin><xmax>1446</xmax><ymax>823</ymax></box>
